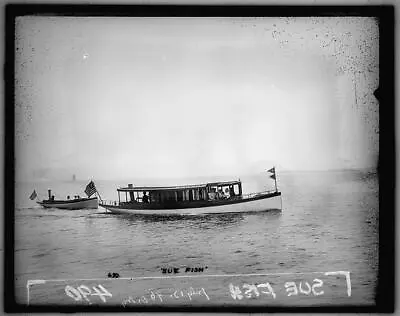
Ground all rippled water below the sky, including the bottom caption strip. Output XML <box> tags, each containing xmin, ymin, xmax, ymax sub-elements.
<box><xmin>15</xmin><ymin>171</ymin><xmax>379</xmax><ymax>306</ymax></box>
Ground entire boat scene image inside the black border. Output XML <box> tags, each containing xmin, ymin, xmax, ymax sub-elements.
<box><xmin>9</xmin><ymin>6</ymin><xmax>386</xmax><ymax>310</ymax></box>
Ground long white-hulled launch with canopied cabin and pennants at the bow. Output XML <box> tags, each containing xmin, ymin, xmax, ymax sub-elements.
<box><xmin>99</xmin><ymin>168</ymin><xmax>282</xmax><ymax>215</ymax></box>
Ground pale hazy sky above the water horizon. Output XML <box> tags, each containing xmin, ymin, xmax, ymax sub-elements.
<box><xmin>15</xmin><ymin>16</ymin><xmax>379</xmax><ymax>179</ymax></box>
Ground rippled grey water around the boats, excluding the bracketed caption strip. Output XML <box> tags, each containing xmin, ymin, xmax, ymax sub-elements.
<box><xmin>15</xmin><ymin>171</ymin><xmax>379</xmax><ymax>305</ymax></box>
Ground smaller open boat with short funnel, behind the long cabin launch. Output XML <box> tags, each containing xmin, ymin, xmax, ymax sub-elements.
<box><xmin>30</xmin><ymin>181</ymin><xmax>99</xmax><ymax>210</ymax></box>
